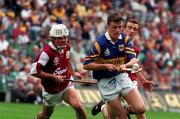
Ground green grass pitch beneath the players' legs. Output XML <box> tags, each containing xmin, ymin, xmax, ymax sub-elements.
<box><xmin>0</xmin><ymin>103</ymin><xmax>180</xmax><ymax>119</ymax></box>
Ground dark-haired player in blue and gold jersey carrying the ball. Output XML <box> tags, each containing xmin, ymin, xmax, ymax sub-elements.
<box><xmin>83</xmin><ymin>12</ymin><xmax>145</xmax><ymax>119</ymax></box>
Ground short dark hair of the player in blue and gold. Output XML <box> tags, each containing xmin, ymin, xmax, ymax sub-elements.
<box><xmin>107</xmin><ymin>12</ymin><xmax>123</xmax><ymax>25</ymax></box>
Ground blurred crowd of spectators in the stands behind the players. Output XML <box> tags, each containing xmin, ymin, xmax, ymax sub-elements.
<box><xmin>0</xmin><ymin>0</ymin><xmax>180</xmax><ymax>103</ymax></box>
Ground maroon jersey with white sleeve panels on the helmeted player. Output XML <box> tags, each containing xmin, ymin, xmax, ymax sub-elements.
<box><xmin>31</xmin><ymin>42</ymin><xmax>71</xmax><ymax>93</ymax></box>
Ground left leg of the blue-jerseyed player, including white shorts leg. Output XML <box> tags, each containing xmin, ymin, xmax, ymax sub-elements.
<box><xmin>98</xmin><ymin>77</ymin><xmax>127</xmax><ymax>119</ymax></box>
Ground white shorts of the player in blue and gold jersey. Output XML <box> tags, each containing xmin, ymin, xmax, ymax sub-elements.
<box><xmin>98</xmin><ymin>73</ymin><xmax>136</xmax><ymax>102</ymax></box>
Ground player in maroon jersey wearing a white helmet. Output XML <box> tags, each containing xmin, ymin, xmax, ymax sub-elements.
<box><xmin>31</xmin><ymin>24</ymin><xmax>87</xmax><ymax>119</ymax></box>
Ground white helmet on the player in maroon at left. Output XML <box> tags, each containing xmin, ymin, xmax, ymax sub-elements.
<box><xmin>49</xmin><ymin>24</ymin><xmax>69</xmax><ymax>37</ymax></box>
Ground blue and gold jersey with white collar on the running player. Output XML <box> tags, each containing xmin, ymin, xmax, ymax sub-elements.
<box><xmin>84</xmin><ymin>32</ymin><xmax>136</xmax><ymax>80</ymax></box>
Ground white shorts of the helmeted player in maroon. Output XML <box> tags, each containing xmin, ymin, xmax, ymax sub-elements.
<box><xmin>42</xmin><ymin>77</ymin><xmax>74</xmax><ymax>106</ymax></box>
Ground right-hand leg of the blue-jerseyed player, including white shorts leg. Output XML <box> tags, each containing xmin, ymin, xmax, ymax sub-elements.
<box><xmin>116</xmin><ymin>73</ymin><xmax>145</xmax><ymax>114</ymax></box>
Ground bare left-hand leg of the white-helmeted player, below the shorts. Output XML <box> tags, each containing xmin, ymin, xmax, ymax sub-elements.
<box><xmin>35</xmin><ymin>104</ymin><xmax>54</xmax><ymax>119</ymax></box>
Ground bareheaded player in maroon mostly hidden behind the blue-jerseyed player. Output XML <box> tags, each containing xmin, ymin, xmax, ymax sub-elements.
<box><xmin>92</xmin><ymin>18</ymin><xmax>153</xmax><ymax>119</ymax></box>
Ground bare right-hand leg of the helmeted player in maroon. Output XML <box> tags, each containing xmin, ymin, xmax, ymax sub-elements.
<box><xmin>63</xmin><ymin>88</ymin><xmax>87</xmax><ymax>119</ymax></box>
